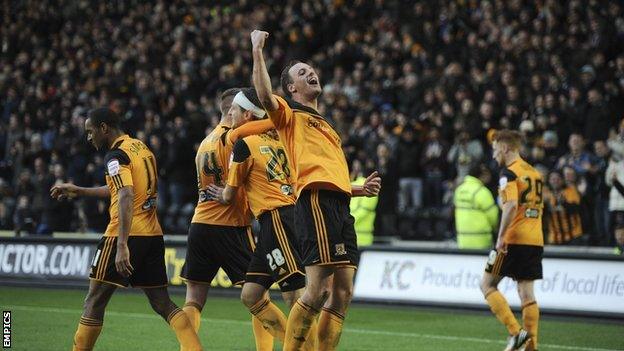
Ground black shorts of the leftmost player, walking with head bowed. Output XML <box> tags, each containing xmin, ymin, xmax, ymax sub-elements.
<box><xmin>89</xmin><ymin>235</ymin><xmax>169</xmax><ymax>288</ymax></box>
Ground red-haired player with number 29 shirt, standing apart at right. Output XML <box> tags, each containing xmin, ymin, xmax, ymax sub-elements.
<box><xmin>481</xmin><ymin>130</ymin><xmax>544</xmax><ymax>350</ymax></box>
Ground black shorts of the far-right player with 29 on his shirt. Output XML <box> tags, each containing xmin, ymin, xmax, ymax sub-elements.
<box><xmin>485</xmin><ymin>245</ymin><xmax>544</xmax><ymax>280</ymax></box>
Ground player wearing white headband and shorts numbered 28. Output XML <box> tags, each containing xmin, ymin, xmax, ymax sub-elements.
<box><xmin>211</xmin><ymin>89</ymin><xmax>316</xmax><ymax>350</ymax></box>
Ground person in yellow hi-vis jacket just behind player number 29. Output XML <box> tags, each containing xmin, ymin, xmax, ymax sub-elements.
<box><xmin>453</xmin><ymin>166</ymin><xmax>498</xmax><ymax>249</ymax></box>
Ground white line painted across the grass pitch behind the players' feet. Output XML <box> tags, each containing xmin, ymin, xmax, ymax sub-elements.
<box><xmin>7</xmin><ymin>305</ymin><xmax>622</xmax><ymax>351</ymax></box>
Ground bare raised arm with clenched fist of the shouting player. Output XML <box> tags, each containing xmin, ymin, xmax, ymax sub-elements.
<box><xmin>251</xmin><ymin>30</ymin><xmax>279</xmax><ymax>112</ymax></box>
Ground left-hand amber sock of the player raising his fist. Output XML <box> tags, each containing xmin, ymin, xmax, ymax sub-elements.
<box><xmin>284</xmin><ymin>299</ymin><xmax>319</xmax><ymax>351</ymax></box>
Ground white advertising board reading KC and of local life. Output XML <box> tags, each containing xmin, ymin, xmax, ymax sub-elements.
<box><xmin>354</xmin><ymin>247</ymin><xmax>624</xmax><ymax>318</ymax></box>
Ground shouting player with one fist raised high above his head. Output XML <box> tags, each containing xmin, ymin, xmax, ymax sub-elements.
<box><xmin>251</xmin><ymin>30</ymin><xmax>381</xmax><ymax>350</ymax></box>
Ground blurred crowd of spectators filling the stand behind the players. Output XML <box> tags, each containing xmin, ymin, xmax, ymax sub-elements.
<box><xmin>0</xmin><ymin>0</ymin><xmax>624</xmax><ymax>245</ymax></box>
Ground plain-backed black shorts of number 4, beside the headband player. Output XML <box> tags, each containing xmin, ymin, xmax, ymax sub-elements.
<box><xmin>180</xmin><ymin>223</ymin><xmax>256</xmax><ymax>285</ymax></box>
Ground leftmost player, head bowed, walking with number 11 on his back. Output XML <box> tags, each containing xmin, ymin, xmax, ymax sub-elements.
<box><xmin>50</xmin><ymin>108</ymin><xmax>202</xmax><ymax>351</ymax></box>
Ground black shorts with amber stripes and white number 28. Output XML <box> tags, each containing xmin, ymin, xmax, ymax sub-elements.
<box><xmin>247</xmin><ymin>206</ymin><xmax>305</xmax><ymax>292</ymax></box>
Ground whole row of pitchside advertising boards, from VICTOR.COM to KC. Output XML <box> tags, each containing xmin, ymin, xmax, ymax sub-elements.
<box><xmin>0</xmin><ymin>234</ymin><xmax>624</xmax><ymax>318</ymax></box>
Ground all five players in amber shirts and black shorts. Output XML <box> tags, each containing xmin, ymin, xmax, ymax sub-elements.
<box><xmin>51</xmin><ymin>30</ymin><xmax>543</xmax><ymax>351</ymax></box>
